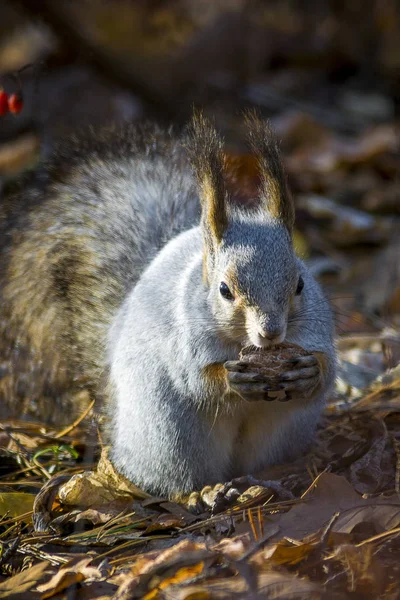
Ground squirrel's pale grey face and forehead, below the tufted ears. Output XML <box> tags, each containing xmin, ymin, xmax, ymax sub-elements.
<box><xmin>209</xmin><ymin>211</ymin><xmax>300</xmax><ymax>347</ymax></box>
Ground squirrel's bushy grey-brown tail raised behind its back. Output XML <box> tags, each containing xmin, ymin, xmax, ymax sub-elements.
<box><xmin>0</xmin><ymin>119</ymin><xmax>199</xmax><ymax>418</ymax></box>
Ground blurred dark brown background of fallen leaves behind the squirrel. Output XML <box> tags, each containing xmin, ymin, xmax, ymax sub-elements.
<box><xmin>0</xmin><ymin>0</ymin><xmax>400</xmax><ymax>412</ymax></box>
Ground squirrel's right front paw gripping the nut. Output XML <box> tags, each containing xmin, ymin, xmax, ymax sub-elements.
<box><xmin>279</xmin><ymin>354</ymin><xmax>322</xmax><ymax>398</ymax></box>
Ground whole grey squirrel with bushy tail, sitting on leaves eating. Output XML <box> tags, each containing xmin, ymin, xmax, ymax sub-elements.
<box><xmin>0</xmin><ymin>114</ymin><xmax>335</xmax><ymax>498</ymax></box>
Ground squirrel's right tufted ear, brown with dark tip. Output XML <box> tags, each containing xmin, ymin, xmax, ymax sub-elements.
<box><xmin>245</xmin><ymin>111</ymin><xmax>294</xmax><ymax>232</ymax></box>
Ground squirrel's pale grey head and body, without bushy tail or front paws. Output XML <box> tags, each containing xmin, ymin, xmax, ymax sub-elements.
<box><xmin>109</xmin><ymin>119</ymin><xmax>335</xmax><ymax>495</ymax></box>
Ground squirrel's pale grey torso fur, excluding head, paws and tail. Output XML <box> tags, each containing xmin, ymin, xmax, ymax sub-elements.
<box><xmin>109</xmin><ymin>228</ymin><xmax>333</xmax><ymax>494</ymax></box>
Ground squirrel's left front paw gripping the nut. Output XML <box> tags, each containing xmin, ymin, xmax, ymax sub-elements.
<box><xmin>224</xmin><ymin>360</ymin><xmax>282</xmax><ymax>402</ymax></box>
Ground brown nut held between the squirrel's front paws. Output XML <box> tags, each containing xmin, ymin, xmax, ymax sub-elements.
<box><xmin>239</xmin><ymin>342</ymin><xmax>310</xmax><ymax>401</ymax></box>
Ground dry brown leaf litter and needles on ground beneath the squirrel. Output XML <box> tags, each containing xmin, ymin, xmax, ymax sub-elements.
<box><xmin>0</xmin><ymin>358</ymin><xmax>400</xmax><ymax>600</ymax></box>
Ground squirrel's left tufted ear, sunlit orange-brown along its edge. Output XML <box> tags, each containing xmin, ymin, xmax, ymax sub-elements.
<box><xmin>187</xmin><ymin>113</ymin><xmax>228</xmax><ymax>247</ymax></box>
